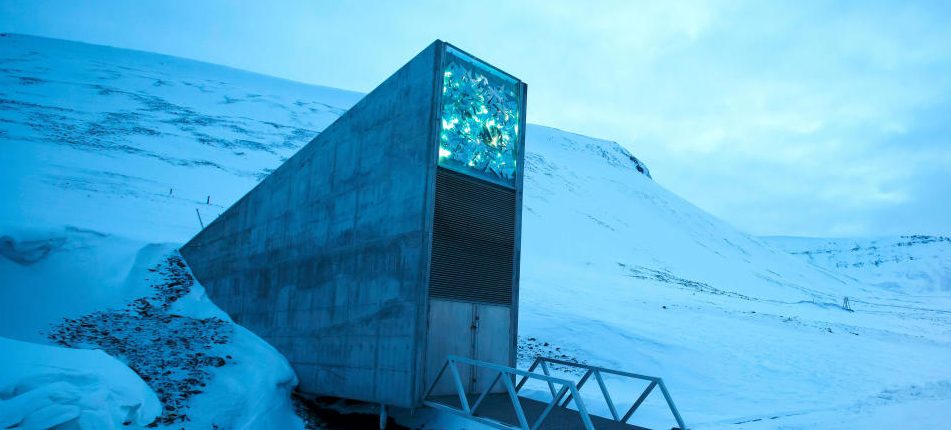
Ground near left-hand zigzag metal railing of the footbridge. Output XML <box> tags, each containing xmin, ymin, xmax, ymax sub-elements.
<box><xmin>423</xmin><ymin>355</ymin><xmax>595</xmax><ymax>430</ymax></box>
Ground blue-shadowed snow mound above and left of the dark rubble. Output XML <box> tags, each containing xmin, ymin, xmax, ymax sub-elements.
<box><xmin>0</xmin><ymin>226</ymin><xmax>158</xmax><ymax>342</ymax></box>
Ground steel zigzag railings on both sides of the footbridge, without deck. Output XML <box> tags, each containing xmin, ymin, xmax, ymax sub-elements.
<box><xmin>423</xmin><ymin>355</ymin><xmax>687</xmax><ymax>430</ymax></box>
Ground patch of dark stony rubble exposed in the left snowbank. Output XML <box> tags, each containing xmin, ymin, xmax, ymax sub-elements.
<box><xmin>48</xmin><ymin>254</ymin><xmax>232</xmax><ymax>427</ymax></box>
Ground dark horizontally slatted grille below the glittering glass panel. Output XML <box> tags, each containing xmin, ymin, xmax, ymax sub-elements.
<box><xmin>429</xmin><ymin>168</ymin><xmax>515</xmax><ymax>305</ymax></box>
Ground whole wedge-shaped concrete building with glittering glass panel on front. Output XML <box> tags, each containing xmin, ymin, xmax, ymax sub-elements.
<box><xmin>181</xmin><ymin>41</ymin><xmax>526</xmax><ymax>407</ymax></box>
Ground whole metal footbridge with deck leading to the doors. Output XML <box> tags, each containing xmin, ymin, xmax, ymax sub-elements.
<box><xmin>423</xmin><ymin>355</ymin><xmax>687</xmax><ymax>430</ymax></box>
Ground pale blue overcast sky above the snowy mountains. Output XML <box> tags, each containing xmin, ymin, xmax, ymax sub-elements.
<box><xmin>0</xmin><ymin>0</ymin><xmax>951</xmax><ymax>236</ymax></box>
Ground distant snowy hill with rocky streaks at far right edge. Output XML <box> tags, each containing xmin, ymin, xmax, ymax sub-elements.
<box><xmin>763</xmin><ymin>236</ymin><xmax>951</xmax><ymax>295</ymax></box>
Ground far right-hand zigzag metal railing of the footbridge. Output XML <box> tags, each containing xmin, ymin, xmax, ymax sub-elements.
<box><xmin>515</xmin><ymin>357</ymin><xmax>687</xmax><ymax>429</ymax></box>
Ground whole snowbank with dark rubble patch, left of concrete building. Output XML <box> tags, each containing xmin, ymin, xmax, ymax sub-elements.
<box><xmin>0</xmin><ymin>228</ymin><xmax>303</xmax><ymax>429</ymax></box>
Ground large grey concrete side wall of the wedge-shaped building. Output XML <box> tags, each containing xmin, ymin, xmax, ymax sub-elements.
<box><xmin>181</xmin><ymin>42</ymin><xmax>441</xmax><ymax>407</ymax></box>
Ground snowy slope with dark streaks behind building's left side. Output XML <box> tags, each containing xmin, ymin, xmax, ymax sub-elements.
<box><xmin>0</xmin><ymin>35</ymin><xmax>360</xmax><ymax>242</ymax></box>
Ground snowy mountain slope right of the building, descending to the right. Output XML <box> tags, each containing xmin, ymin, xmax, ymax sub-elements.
<box><xmin>519</xmin><ymin>127</ymin><xmax>951</xmax><ymax>428</ymax></box>
